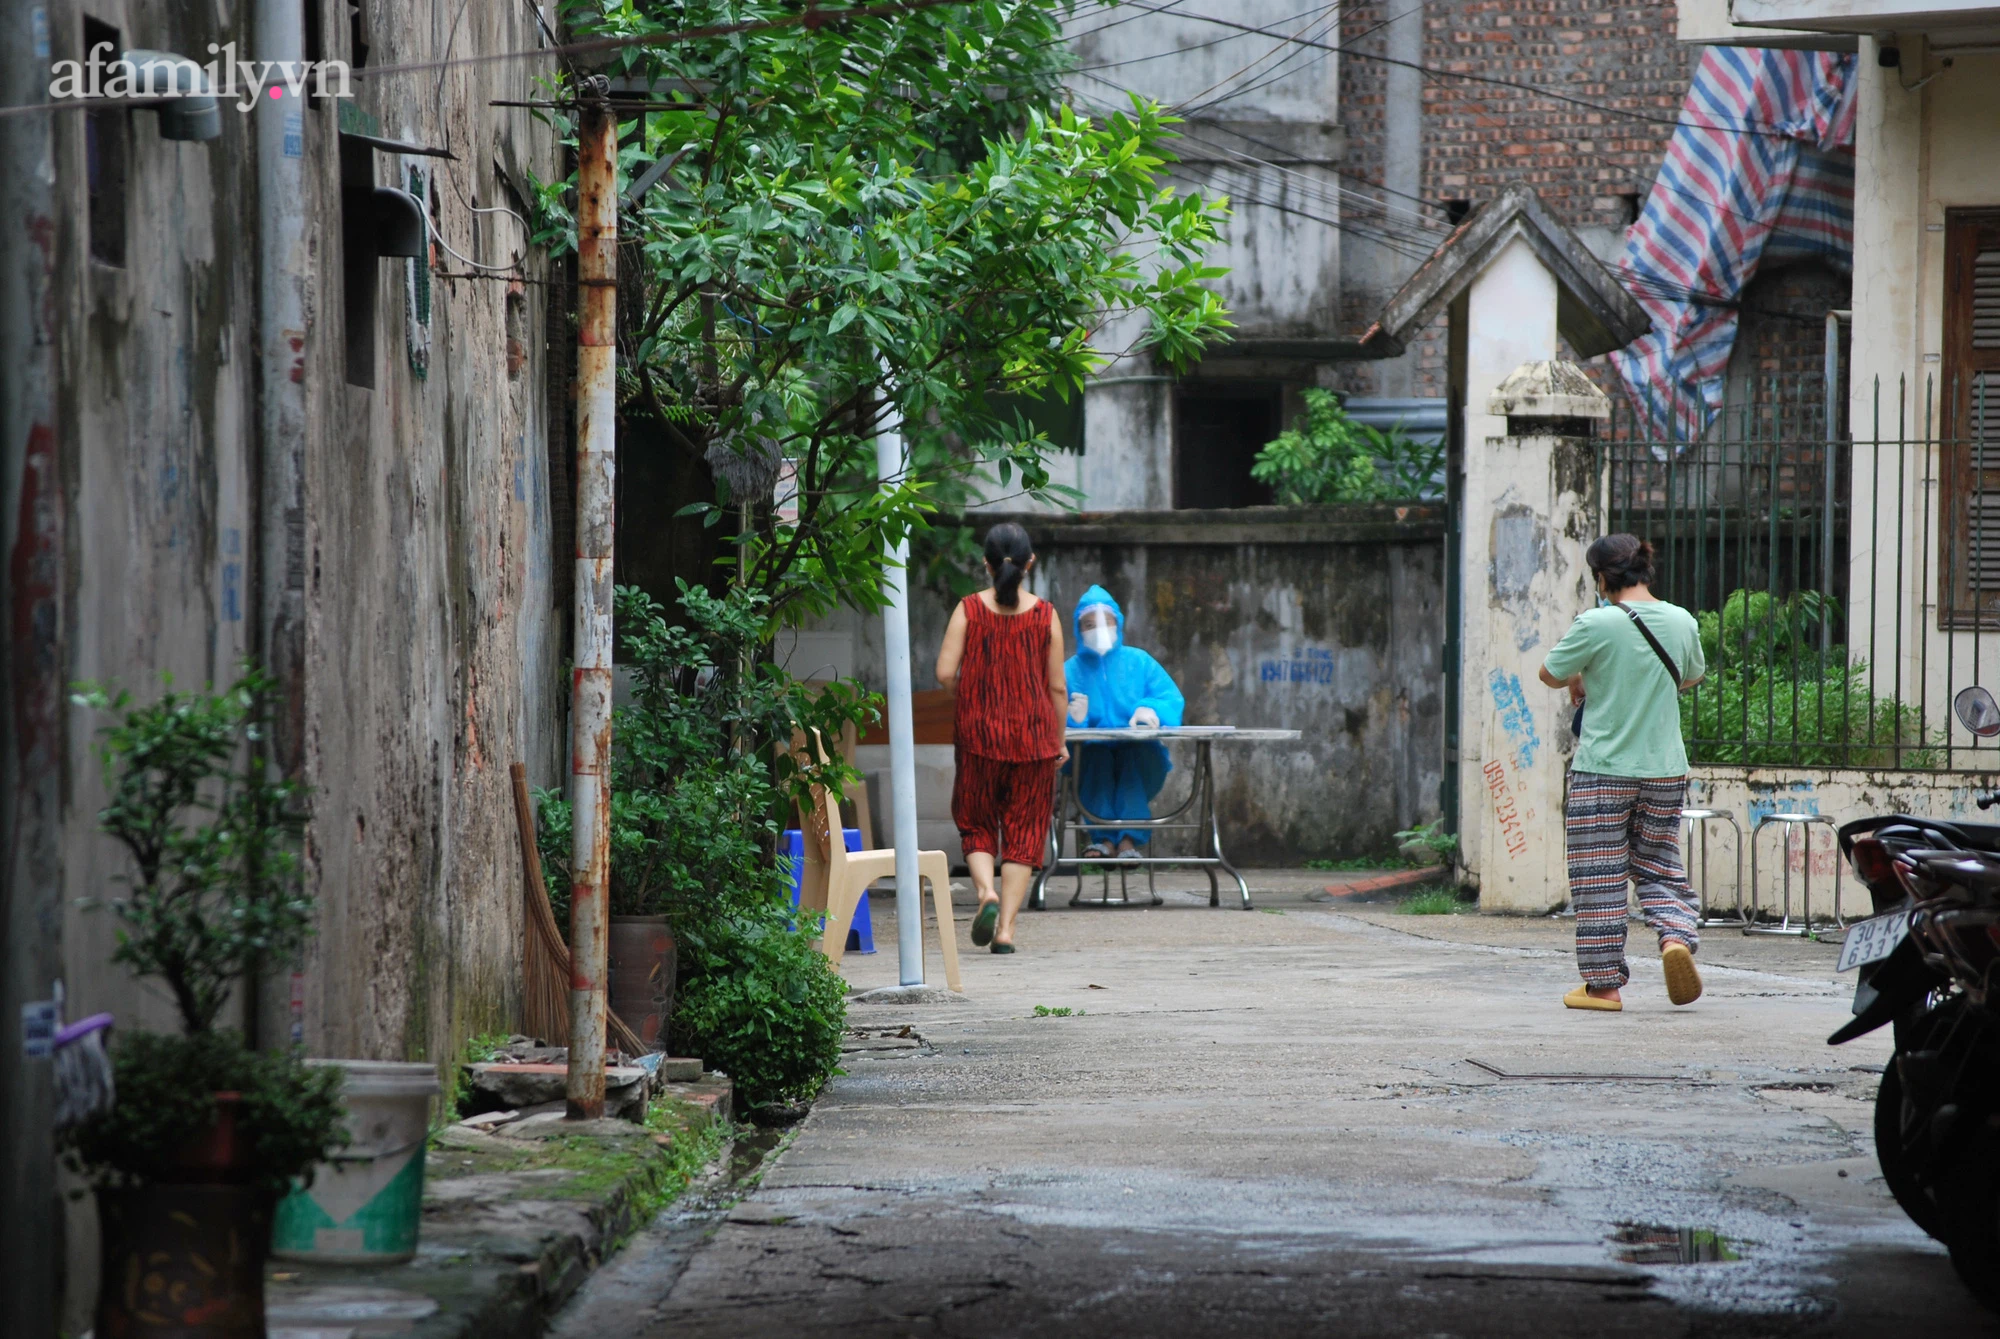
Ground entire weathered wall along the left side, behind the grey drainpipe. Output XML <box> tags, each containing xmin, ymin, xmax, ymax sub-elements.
<box><xmin>34</xmin><ymin>0</ymin><xmax>564</xmax><ymax>1329</ymax></box>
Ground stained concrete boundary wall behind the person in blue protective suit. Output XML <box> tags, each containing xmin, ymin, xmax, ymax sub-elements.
<box><xmin>830</xmin><ymin>506</ymin><xmax>1444</xmax><ymax>865</ymax></box>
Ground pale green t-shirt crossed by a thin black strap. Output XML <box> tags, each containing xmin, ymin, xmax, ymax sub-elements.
<box><xmin>1544</xmin><ymin>600</ymin><xmax>1708</xmax><ymax>777</ymax></box>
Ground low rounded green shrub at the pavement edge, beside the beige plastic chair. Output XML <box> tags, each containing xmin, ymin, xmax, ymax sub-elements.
<box><xmin>672</xmin><ymin>911</ymin><xmax>846</xmax><ymax>1107</ymax></box>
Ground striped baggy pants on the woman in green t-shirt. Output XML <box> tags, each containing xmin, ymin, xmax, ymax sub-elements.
<box><xmin>1564</xmin><ymin>771</ymin><xmax>1702</xmax><ymax>987</ymax></box>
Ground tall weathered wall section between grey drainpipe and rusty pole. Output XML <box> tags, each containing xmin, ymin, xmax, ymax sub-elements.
<box><xmin>304</xmin><ymin>6</ymin><xmax>566</xmax><ymax>1063</ymax></box>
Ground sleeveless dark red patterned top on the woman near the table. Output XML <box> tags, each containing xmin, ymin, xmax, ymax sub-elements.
<box><xmin>952</xmin><ymin>596</ymin><xmax>1062</xmax><ymax>763</ymax></box>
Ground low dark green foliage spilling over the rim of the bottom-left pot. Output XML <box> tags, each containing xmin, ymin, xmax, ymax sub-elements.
<box><xmin>60</xmin><ymin>1031</ymin><xmax>348</xmax><ymax>1193</ymax></box>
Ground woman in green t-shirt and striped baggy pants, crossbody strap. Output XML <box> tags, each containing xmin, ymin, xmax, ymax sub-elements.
<box><xmin>1542</xmin><ymin>536</ymin><xmax>1708</xmax><ymax>1009</ymax></box>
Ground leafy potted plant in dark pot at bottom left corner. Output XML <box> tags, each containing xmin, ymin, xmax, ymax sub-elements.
<box><xmin>64</xmin><ymin>668</ymin><xmax>346</xmax><ymax>1337</ymax></box>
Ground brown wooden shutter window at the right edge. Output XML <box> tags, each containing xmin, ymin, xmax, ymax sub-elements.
<box><xmin>1936</xmin><ymin>210</ymin><xmax>2000</xmax><ymax>628</ymax></box>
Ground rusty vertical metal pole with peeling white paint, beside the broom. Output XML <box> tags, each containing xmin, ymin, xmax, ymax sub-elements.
<box><xmin>564</xmin><ymin>88</ymin><xmax>618</xmax><ymax>1121</ymax></box>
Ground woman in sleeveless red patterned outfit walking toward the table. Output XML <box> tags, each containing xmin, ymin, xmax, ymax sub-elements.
<box><xmin>938</xmin><ymin>522</ymin><xmax>1070</xmax><ymax>953</ymax></box>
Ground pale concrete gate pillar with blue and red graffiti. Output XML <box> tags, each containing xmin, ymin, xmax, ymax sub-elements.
<box><xmin>1458</xmin><ymin>361</ymin><xmax>1610</xmax><ymax>911</ymax></box>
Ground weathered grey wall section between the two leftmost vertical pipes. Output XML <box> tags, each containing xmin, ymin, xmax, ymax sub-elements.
<box><xmin>50</xmin><ymin>4</ymin><xmax>258</xmax><ymax>1027</ymax></box>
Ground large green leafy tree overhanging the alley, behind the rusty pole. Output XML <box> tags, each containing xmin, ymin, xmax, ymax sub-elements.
<box><xmin>538</xmin><ymin>0</ymin><xmax>1228</xmax><ymax>622</ymax></box>
